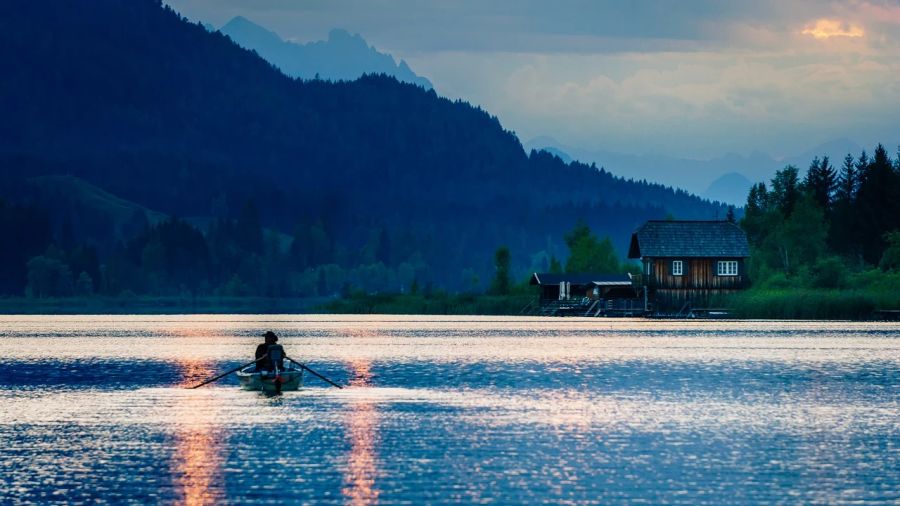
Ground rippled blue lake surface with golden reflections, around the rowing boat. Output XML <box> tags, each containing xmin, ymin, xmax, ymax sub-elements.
<box><xmin>0</xmin><ymin>315</ymin><xmax>900</xmax><ymax>504</ymax></box>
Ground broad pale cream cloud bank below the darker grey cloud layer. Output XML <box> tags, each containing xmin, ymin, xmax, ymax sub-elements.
<box><xmin>413</xmin><ymin>44</ymin><xmax>900</xmax><ymax>158</ymax></box>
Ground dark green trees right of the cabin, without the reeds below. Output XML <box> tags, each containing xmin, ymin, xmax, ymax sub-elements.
<box><xmin>741</xmin><ymin>144</ymin><xmax>900</xmax><ymax>288</ymax></box>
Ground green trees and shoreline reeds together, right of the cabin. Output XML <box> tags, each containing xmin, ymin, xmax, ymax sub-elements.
<box><xmin>727</xmin><ymin>144</ymin><xmax>900</xmax><ymax>318</ymax></box>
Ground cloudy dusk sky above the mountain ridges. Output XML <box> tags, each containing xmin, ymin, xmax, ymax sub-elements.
<box><xmin>167</xmin><ymin>0</ymin><xmax>900</xmax><ymax>159</ymax></box>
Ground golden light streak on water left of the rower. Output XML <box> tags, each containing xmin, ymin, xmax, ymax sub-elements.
<box><xmin>172</xmin><ymin>360</ymin><xmax>224</xmax><ymax>506</ymax></box>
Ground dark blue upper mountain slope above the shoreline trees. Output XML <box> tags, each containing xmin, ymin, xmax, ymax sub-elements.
<box><xmin>0</xmin><ymin>0</ymin><xmax>725</xmax><ymax>288</ymax></box>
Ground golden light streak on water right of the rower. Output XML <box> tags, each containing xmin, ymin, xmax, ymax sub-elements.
<box><xmin>341</xmin><ymin>360</ymin><xmax>378</xmax><ymax>505</ymax></box>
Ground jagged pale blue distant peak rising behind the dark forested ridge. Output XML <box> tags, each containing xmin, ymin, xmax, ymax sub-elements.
<box><xmin>219</xmin><ymin>16</ymin><xmax>432</xmax><ymax>89</ymax></box>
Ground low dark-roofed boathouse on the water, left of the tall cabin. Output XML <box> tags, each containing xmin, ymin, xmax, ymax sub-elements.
<box><xmin>529</xmin><ymin>272</ymin><xmax>644</xmax><ymax>316</ymax></box>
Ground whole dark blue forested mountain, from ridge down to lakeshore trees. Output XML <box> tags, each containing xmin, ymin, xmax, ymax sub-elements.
<box><xmin>0</xmin><ymin>0</ymin><xmax>726</xmax><ymax>304</ymax></box>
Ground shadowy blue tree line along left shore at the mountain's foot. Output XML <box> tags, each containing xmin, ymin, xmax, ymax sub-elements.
<box><xmin>0</xmin><ymin>200</ymin><xmax>442</xmax><ymax>298</ymax></box>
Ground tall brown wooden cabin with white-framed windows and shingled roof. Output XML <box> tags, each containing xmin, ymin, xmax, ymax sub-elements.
<box><xmin>628</xmin><ymin>220</ymin><xmax>750</xmax><ymax>314</ymax></box>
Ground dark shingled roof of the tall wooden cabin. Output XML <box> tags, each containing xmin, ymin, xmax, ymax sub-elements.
<box><xmin>628</xmin><ymin>220</ymin><xmax>750</xmax><ymax>258</ymax></box>
